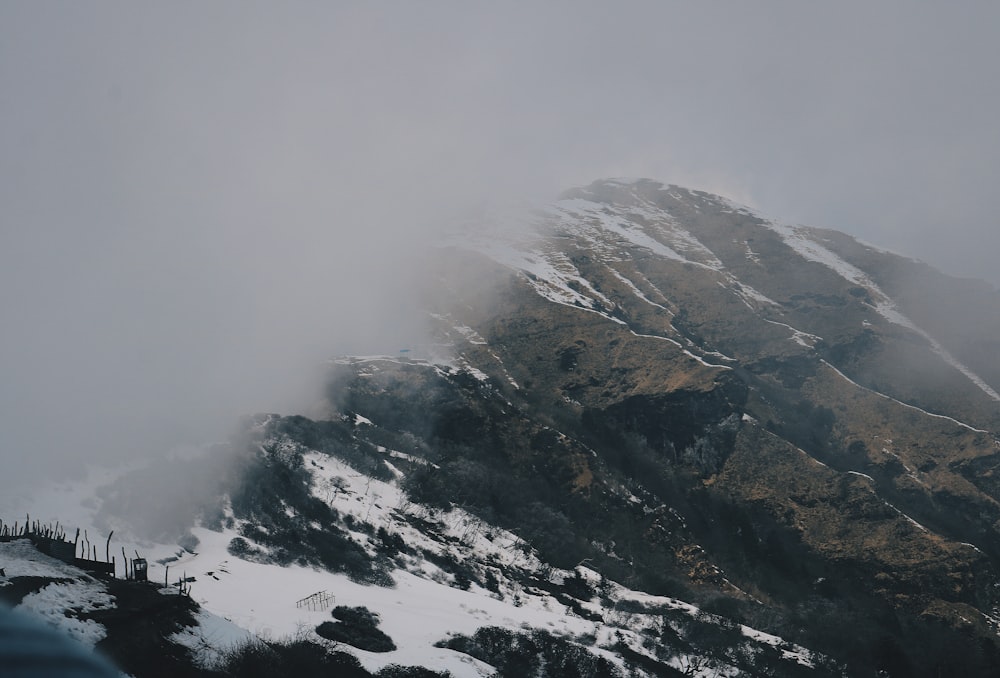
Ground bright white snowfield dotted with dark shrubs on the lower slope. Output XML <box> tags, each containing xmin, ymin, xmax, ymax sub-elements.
<box><xmin>119</xmin><ymin>440</ymin><xmax>820</xmax><ymax>678</ymax></box>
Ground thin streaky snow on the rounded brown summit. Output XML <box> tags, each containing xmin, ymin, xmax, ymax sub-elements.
<box><xmin>460</xmin><ymin>182</ymin><xmax>1000</xmax><ymax>410</ymax></box>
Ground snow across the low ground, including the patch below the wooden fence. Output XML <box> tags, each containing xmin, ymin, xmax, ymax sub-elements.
<box><xmin>0</xmin><ymin>436</ymin><xmax>828</xmax><ymax>678</ymax></box>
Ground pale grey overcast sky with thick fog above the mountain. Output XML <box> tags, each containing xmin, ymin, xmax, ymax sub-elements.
<box><xmin>0</xmin><ymin>2</ymin><xmax>1000</xmax><ymax>494</ymax></box>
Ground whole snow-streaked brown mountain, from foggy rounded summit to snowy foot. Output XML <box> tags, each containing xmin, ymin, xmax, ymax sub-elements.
<box><xmin>0</xmin><ymin>180</ymin><xmax>1000</xmax><ymax>676</ymax></box>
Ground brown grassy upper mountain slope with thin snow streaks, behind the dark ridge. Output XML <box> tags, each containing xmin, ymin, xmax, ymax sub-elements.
<box><xmin>420</xmin><ymin>181</ymin><xmax>1000</xmax><ymax>676</ymax></box>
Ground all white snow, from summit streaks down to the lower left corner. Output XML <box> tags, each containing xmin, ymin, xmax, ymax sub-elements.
<box><xmin>0</xmin><ymin>175</ymin><xmax>1000</xmax><ymax>677</ymax></box>
